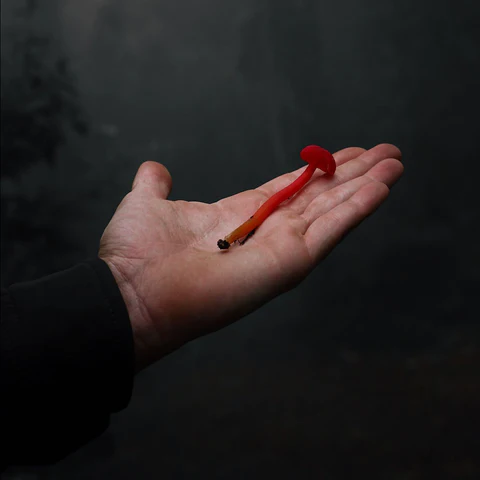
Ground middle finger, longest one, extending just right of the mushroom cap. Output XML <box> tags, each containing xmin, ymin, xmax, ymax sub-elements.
<box><xmin>274</xmin><ymin>144</ymin><xmax>402</xmax><ymax>214</ymax></box>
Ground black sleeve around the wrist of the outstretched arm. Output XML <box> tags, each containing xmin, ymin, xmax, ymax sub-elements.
<box><xmin>0</xmin><ymin>258</ymin><xmax>134</xmax><ymax>469</ymax></box>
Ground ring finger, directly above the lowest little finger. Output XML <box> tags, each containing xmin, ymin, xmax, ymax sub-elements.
<box><xmin>302</xmin><ymin>158</ymin><xmax>403</xmax><ymax>227</ymax></box>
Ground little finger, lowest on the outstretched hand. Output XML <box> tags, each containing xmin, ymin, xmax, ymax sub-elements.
<box><xmin>305</xmin><ymin>182</ymin><xmax>389</xmax><ymax>264</ymax></box>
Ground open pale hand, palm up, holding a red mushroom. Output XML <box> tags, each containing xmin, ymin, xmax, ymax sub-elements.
<box><xmin>99</xmin><ymin>144</ymin><xmax>403</xmax><ymax>371</ymax></box>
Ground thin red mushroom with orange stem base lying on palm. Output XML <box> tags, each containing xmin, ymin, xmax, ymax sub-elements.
<box><xmin>217</xmin><ymin>145</ymin><xmax>336</xmax><ymax>250</ymax></box>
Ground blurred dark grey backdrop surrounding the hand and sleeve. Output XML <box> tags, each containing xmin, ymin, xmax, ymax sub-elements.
<box><xmin>1</xmin><ymin>0</ymin><xmax>480</xmax><ymax>480</ymax></box>
